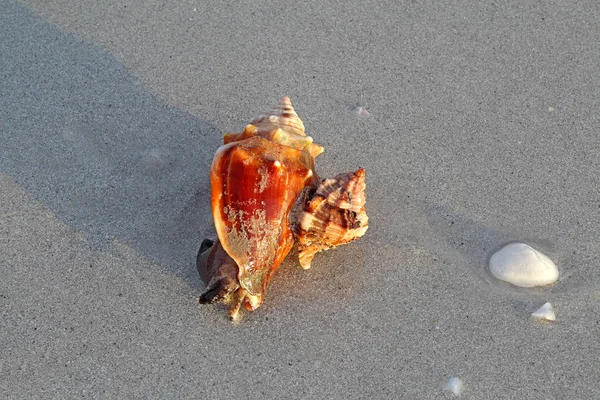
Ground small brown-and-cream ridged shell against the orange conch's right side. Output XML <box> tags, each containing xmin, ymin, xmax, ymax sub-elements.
<box><xmin>294</xmin><ymin>168</ymin><xmax>369</xmax><ymax>269</ymax></box>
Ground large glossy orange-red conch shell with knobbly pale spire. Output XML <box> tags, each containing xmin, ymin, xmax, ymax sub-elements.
<box><xmin>210</xmin><ymin>97</ymin><xmax>322</xmax><ymax>318</ymax></box>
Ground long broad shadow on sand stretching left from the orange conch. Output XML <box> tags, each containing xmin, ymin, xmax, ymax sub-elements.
<box><xmin>0</xmin><ymin>2</ymin><xmax>222</xmax><ymax>287</ymax></box>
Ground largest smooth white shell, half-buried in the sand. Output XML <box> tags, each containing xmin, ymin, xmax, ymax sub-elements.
<box><xmin>490</xmin><ymin>243</ymin><xmax>558</xmax><ymax>287</ymax></box>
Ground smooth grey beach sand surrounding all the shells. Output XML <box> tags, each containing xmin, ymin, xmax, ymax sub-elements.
<box><xmin>0</xmin><ymin>0</ymin><xmax>600</xmax><ymax>399</ymax></box>
